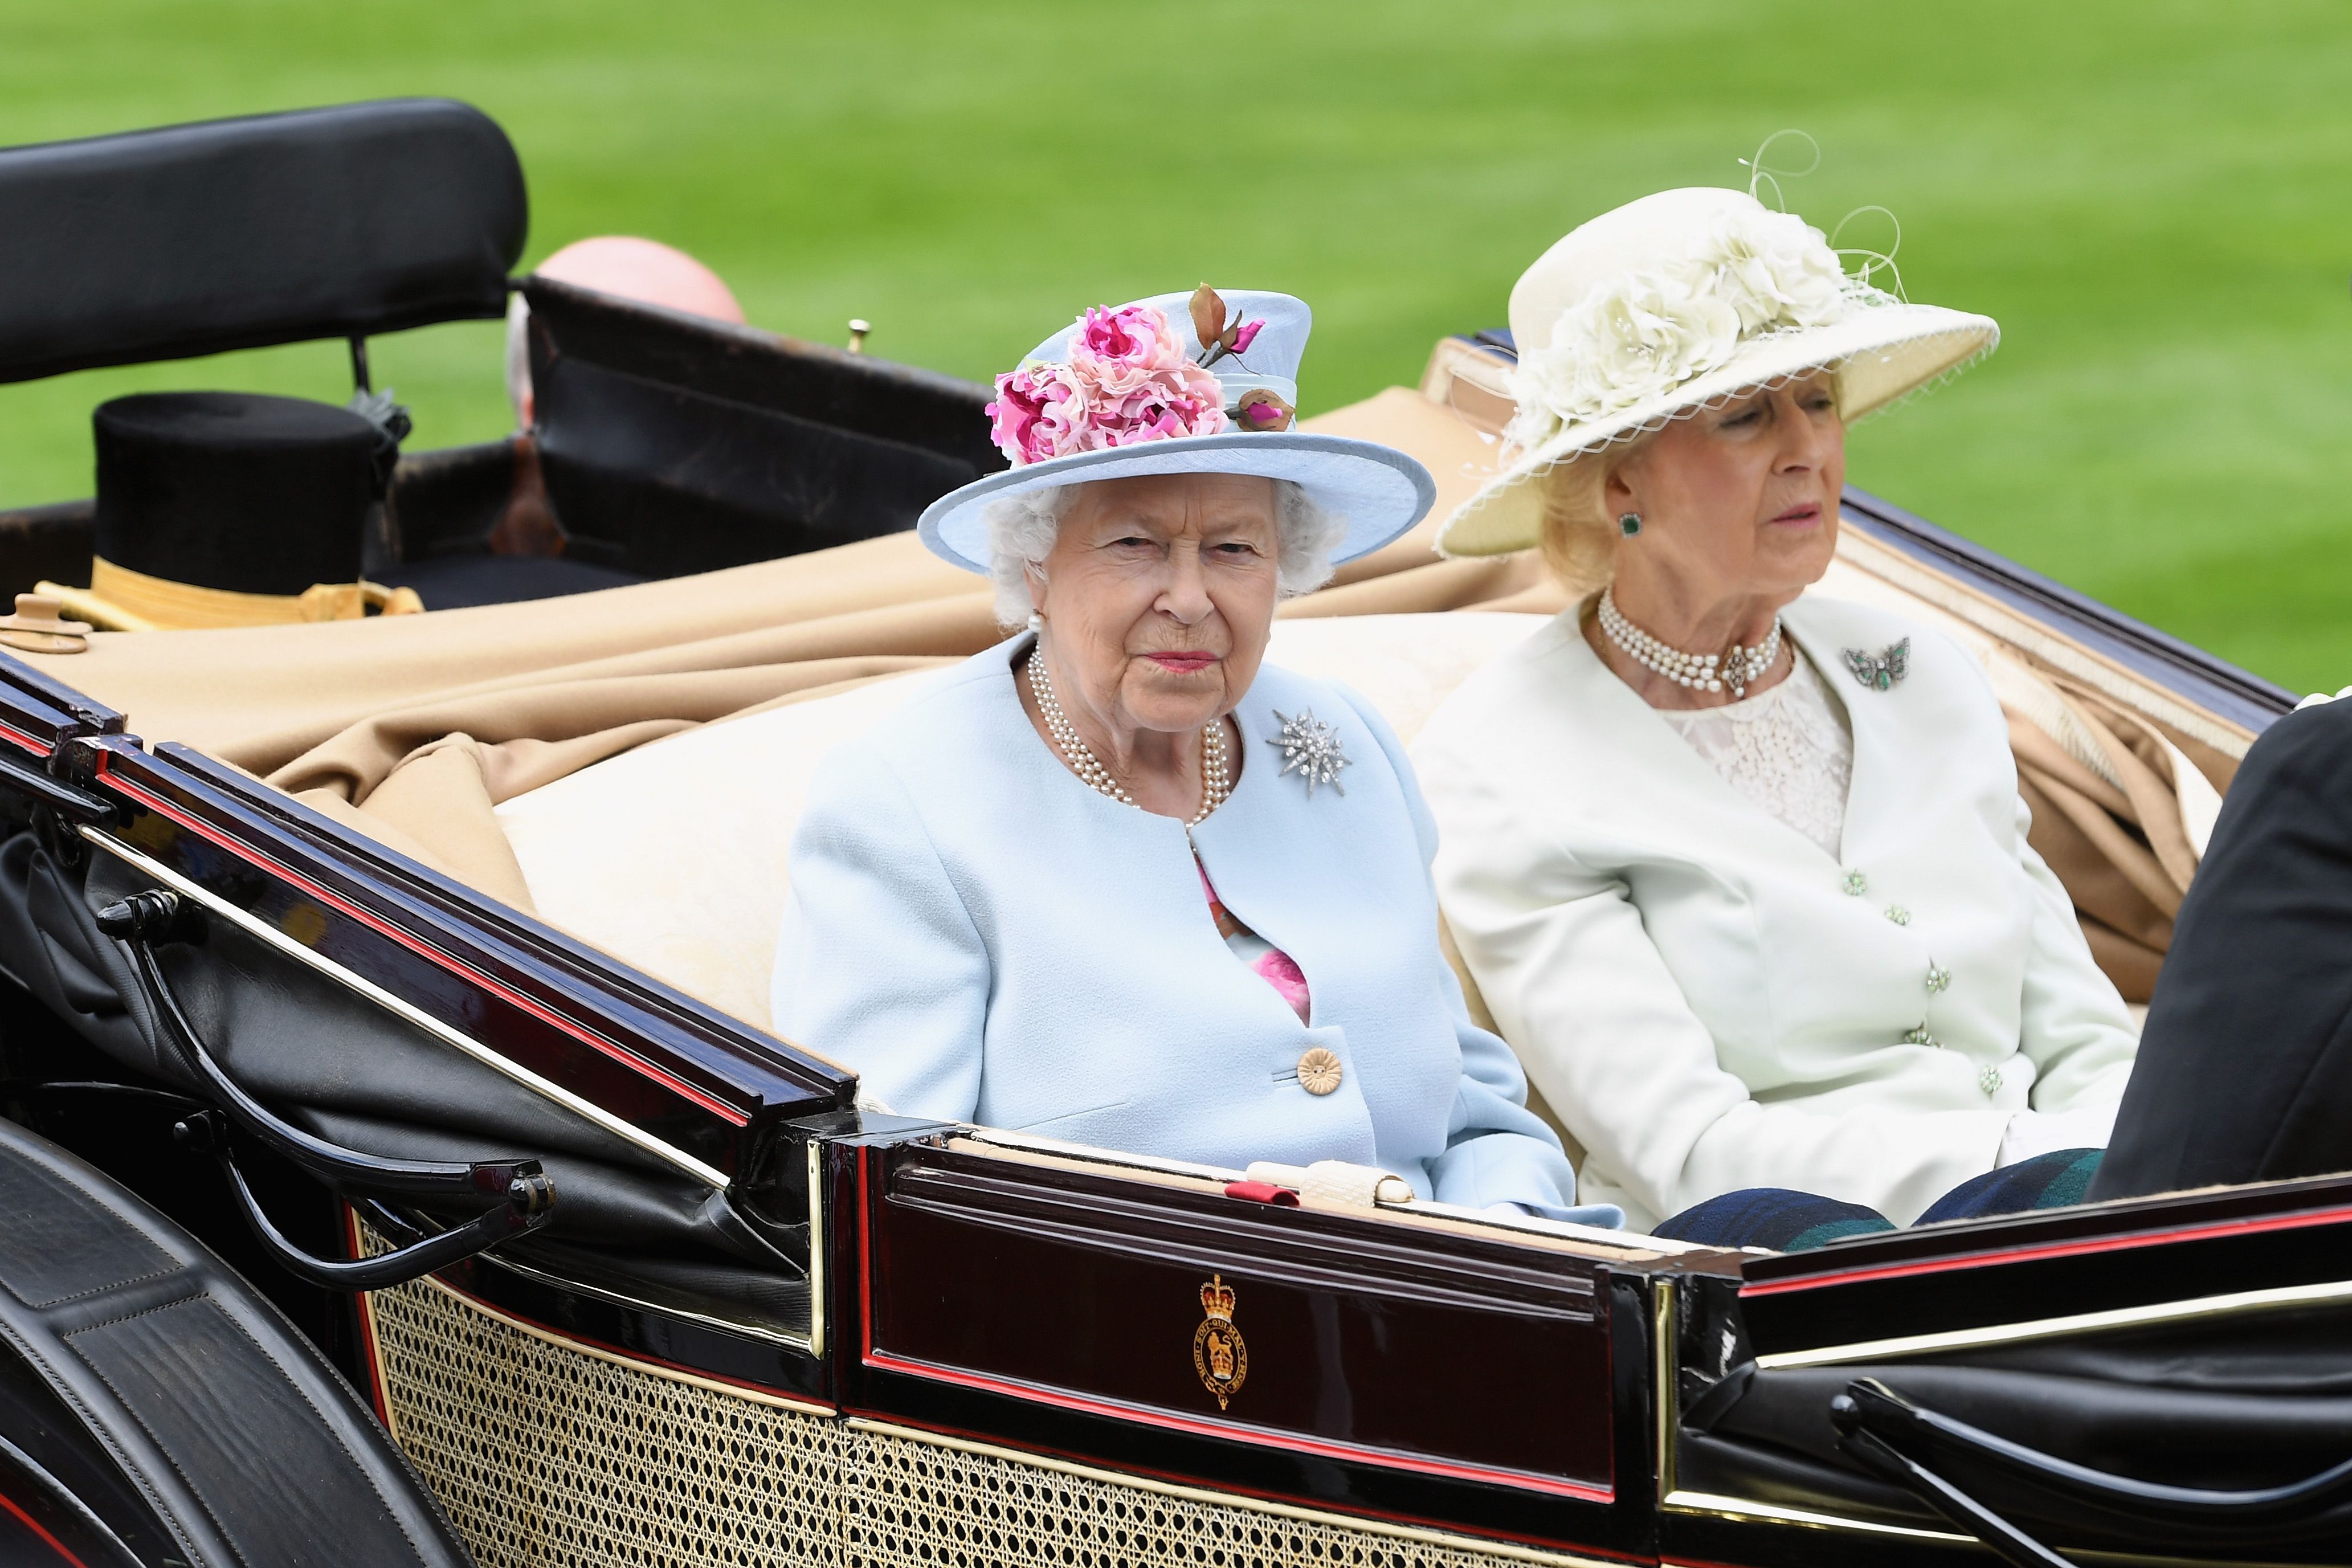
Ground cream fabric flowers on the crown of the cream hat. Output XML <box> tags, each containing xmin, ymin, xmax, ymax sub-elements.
<box><xmin>1505</xmin><ymin>209</ymin><xmax>1858</xmax><ymax>449</ymax></box>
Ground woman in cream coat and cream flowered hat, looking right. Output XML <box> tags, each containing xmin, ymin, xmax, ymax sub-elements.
<box><xmin>1414</xmin><ymin>190</ymin><xmax>2135</xmax><ymax>1246</ymax></box>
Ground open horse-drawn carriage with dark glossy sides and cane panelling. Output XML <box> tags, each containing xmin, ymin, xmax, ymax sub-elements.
<box><xmin>0</xmin><ymin>95</ymin><xmax>2352</xmax><ymax>1566</ymax></box>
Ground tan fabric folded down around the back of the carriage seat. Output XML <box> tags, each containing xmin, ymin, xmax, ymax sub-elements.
<box><xmin>52</xmin><ymin>388</ymin><xmax>2225</xmax><ymax>997</ymax></box>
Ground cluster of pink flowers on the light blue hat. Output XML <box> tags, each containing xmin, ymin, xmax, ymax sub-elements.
<box><xmin>988</xmin><ymin>305</ymin><xmax>1228</xmax><ymax>468</ymax></box>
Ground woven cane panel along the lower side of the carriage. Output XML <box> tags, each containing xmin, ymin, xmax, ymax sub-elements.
<box><xmin>374</xmin><ymin>1281</ymin><xmax>1569</xmax><ymax>1568</ymax></box>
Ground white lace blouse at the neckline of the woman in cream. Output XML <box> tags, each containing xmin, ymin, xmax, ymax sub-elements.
<box><xmin>1658</xmin><ymin>651</ymin><xmax>1853</xmax><ymax>860</ymax></box>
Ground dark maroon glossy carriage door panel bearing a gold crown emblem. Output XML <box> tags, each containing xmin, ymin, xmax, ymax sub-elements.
<box><xmin>861</xmin><ymin>1147</ymin><xmax>1614</xmax><ymax>1502</ymax></box>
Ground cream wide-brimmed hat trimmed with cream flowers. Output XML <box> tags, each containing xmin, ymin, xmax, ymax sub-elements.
<box><xmin>1437</xmin><ymin>176</ymin><xmax>2002</xmax><ymax>555</ymax></box>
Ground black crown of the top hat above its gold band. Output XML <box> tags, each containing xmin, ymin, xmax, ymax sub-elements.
<box><xmin>92</xmin><ymin>393</ymin><xmax>398</xmax><ymax>595</ymax></box>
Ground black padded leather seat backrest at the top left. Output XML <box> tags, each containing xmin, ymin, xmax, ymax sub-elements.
<box><xmin>0</xmin><ymin>99</ymin><xmax>529</xmax><ymax>381</ymax></box>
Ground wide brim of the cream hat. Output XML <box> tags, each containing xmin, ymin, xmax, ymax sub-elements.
<box><xmin>1437</xmin><ymin>305</ymin><xmax>2002</xmax><ymax>555</ymax></box>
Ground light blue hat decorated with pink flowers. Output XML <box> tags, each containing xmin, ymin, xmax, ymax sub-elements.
<box><xmin>915</xmin><ymin>284</ymin><xmax>1437</xmax><ymax>571</ymax></box>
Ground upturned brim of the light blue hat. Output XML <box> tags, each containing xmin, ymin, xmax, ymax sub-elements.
<box><xmin>915</xmin><ymin>430</ymin><xmax>1437</xmax><ymax>571</ymax></box>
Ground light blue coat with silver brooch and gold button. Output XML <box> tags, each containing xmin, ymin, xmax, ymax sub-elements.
<box><xmin>774</xmin><ymin>635</ymin><xmax>1614</xmax><ymax>1222</ymax></box>
